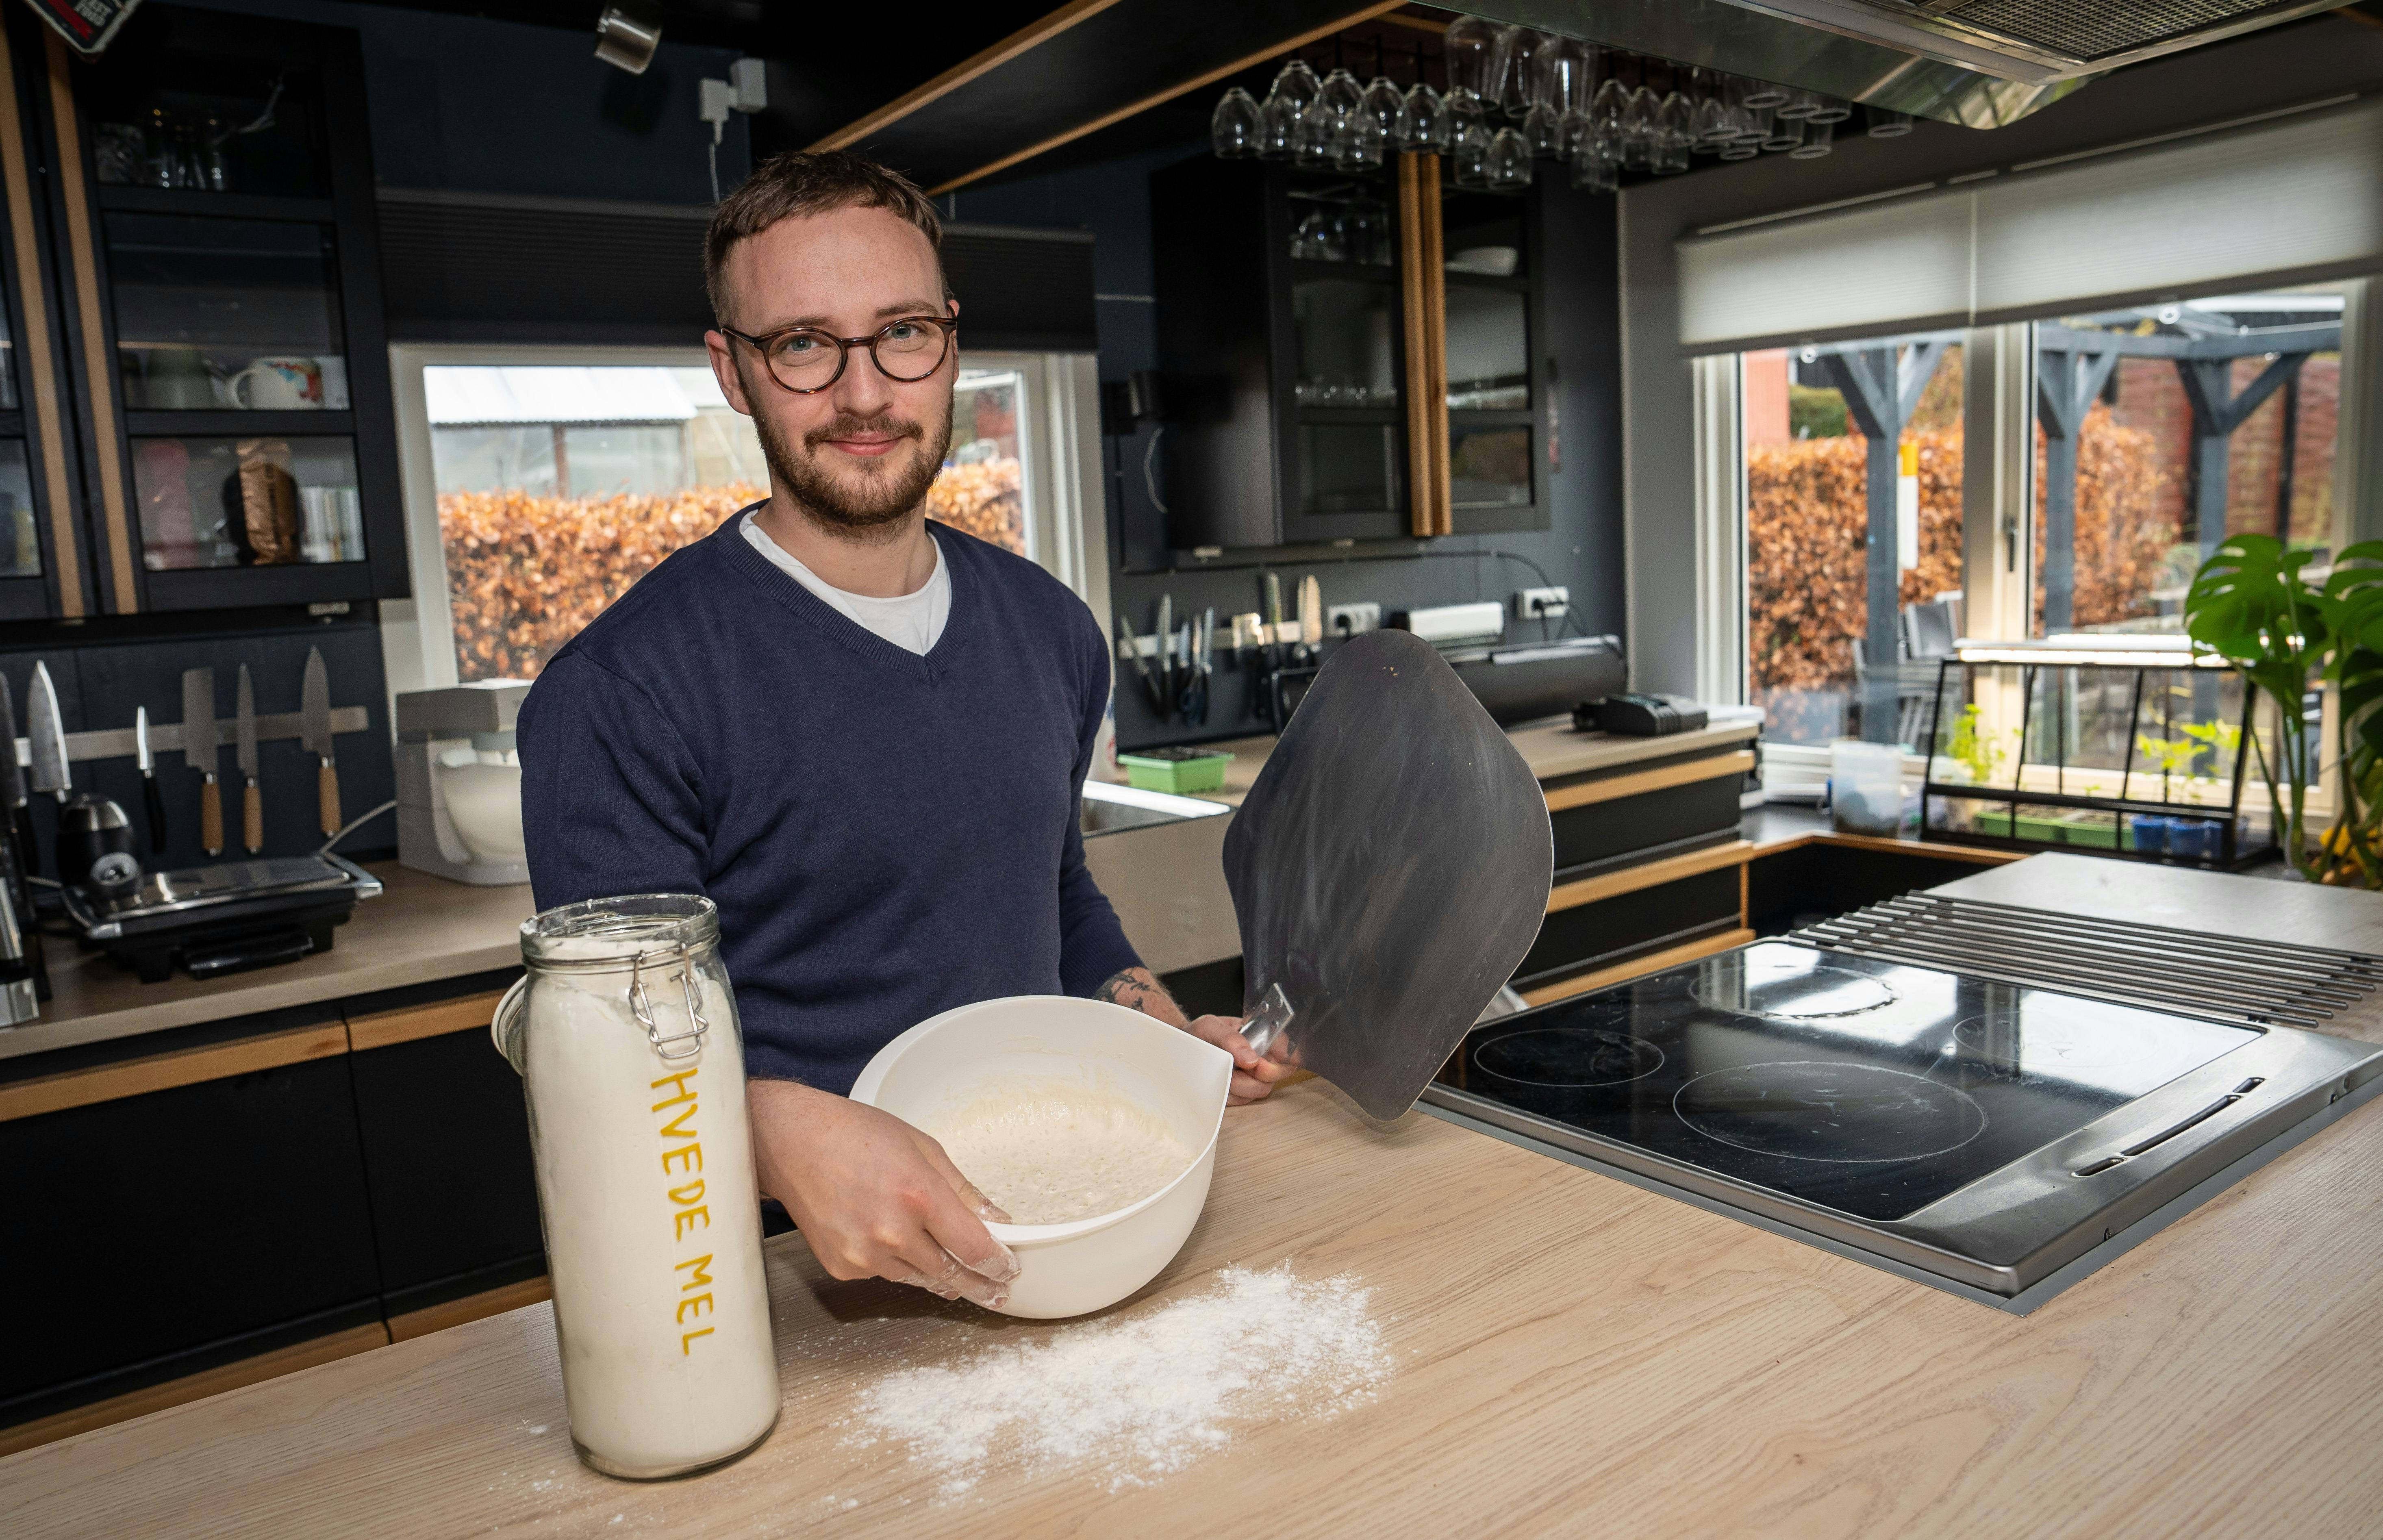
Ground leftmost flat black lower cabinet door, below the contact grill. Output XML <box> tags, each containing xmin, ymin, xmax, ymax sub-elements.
<box><xmin>0</xmin><ymin>1058</ymin><xmax>379</xmax><ymax>1423</ymax></box>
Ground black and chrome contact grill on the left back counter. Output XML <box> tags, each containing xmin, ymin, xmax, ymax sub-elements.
<box><xmin>64</xmin><ymin>854</ymin><xmax>381</xmax><ymax>984</ymax></box>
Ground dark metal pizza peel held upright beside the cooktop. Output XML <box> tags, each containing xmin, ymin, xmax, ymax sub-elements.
<box><xmin>1225</xmin><ymin>629</ymin><xmax>1554</xmax><ymax>1121</ymax></box>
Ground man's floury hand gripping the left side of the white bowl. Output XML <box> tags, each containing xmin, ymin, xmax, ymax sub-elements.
<box><xmin>746</xmin><ymin>1080</ymin><xmax>1018</xmax><ymax>1306</ymax></box>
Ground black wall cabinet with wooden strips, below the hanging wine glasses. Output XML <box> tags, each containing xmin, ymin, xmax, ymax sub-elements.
<box><xmin>1151</xmin><ymin>155</ymin><xmax>1549</xmax><ymax>548</ymax></box>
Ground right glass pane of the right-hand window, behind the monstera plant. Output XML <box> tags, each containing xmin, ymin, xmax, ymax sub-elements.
<box><xmin>2030</xmin><ymin>291</ymin><xmax>2342</xmax><ymax>636</ymax></box>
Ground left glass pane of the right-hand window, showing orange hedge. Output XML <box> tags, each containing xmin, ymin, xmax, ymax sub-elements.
<box><xmin>1740</xmin><ymin>331</ymin><xmax>1961</xmax><ymax>744</ymax></box>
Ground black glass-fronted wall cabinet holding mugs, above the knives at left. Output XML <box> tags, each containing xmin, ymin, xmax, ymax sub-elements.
<box><xmin>0</xmin><ymin>5</ymin><xmax>408</xmax><ymax>617</ymax></box>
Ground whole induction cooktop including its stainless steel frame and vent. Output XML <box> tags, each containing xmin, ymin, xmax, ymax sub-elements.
<box><xmin>1423</xmin><ymin>939</ymin><xmax>2383</xmax><ymax>1309</ymax></box>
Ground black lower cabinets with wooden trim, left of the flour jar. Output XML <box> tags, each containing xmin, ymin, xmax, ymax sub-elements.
<box><xmin>0</xmin><ymin>968</ymin><xmax>529</xmax><ymax>1447</ymax></box>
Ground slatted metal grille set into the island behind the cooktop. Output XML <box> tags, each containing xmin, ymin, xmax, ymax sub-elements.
<box><xmin>1783</xmin><ymin>894</ymin><xmax>2383</xmax><ymax>1027</ymax></box>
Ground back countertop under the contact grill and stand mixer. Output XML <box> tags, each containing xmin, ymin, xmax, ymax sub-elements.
<box><xmin>0</xmin><ymin>860</ymin><xmax>531</xmax><ymax>1058</ymax></box>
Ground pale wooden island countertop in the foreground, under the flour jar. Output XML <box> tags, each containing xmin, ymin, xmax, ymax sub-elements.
<box><xmin>18</xmin><ymin>856</ymin><xmax>2383</xmax><ymax>1540</ymax></box>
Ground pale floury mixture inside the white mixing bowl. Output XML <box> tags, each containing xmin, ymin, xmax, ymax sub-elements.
<box><xmin>927</xmin><ymin>1085</ymin><xmax>1192</xmax><ymax>1225</ymax></box>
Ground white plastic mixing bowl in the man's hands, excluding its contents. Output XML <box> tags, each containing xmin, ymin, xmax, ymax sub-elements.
<box><xmin>853</xmin><ymin>994</ymin><xmax>1232</xmax><ymax>1321</ymax></box>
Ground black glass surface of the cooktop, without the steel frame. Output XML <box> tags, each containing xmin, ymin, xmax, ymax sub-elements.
<box><xmin>1439</xmin><ymin>942</ymin><xmax>2259</xmax><ymax>1221</ymax></box>
